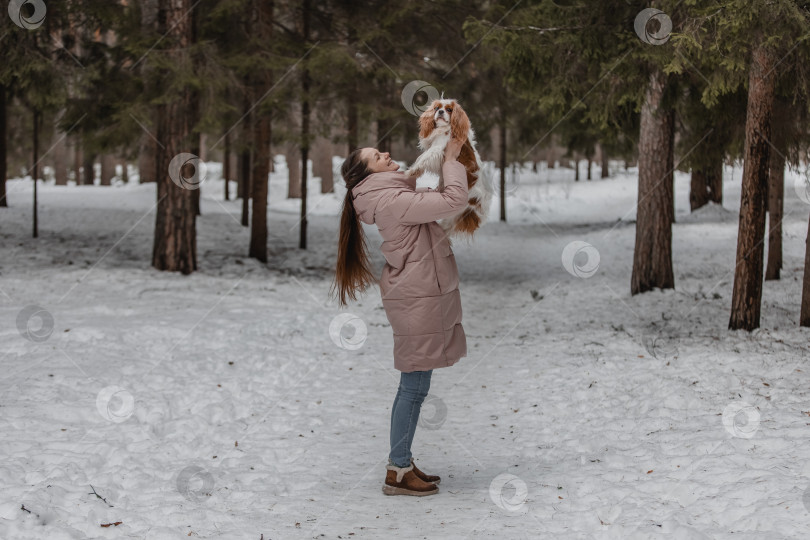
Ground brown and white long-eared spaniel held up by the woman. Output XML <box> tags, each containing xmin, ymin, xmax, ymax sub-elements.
<box><xmin>405</xmin><ymin>99</ymin><xmax>492</xmax><ymax>237</ymax></box>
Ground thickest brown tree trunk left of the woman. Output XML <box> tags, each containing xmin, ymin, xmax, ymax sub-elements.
<box><xmin>152</xmin><ymin>0</ymin><xmax>200</xmax><ymax>274</ymax></box>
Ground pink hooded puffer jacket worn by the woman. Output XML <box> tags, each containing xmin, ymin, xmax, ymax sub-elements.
<box><xmin>352</xmin><ymin>161</ymin><xmax>467</xmax><ymax>372</ymax></box>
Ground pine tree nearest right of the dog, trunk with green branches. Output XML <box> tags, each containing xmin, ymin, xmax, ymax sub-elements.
<box><xmin>468</xmin><ymin>1</ymin><xmax>686</xmax><ymax>294</ymax></box>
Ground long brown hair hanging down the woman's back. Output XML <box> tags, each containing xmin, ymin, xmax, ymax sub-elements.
<box><xmin>330</xmin><ymin>148</ymin><xmax>378</xmax><ymax>306</ymax></box>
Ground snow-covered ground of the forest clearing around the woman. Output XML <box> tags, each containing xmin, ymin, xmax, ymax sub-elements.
<box><xmin>0</xmin><ymin>158</ymin><xmax>810</xmax><ymax>540</ymax></box>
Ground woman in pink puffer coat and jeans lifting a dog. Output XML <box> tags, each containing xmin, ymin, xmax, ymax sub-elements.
<box><xmin>333</xmin><ymin>139</ymin><xmax>467</xmax><ymax>496</ymax></box>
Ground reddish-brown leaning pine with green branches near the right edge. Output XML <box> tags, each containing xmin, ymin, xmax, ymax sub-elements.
<box><xmin>676</xmin><ymin>0</ymin><xmax>810</xmax><ymax>331</ymax></box>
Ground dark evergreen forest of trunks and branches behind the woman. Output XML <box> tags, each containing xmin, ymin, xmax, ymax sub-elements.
<box><xmin>0</xmin><ymin>0</ymin><xmax>810</xmax><ymax>330</ymax></box>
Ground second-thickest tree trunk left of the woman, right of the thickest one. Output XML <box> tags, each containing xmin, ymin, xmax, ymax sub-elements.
<box><xmin>249</xmin><ymin>0</ymin><xmax>273</xmax><ymax>263</ymax></box>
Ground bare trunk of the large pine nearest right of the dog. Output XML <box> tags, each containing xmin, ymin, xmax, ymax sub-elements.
<box><xmin>630</xmin><ymin>71</ymin><xmax>675</xmax><ymax>294</ymax></box>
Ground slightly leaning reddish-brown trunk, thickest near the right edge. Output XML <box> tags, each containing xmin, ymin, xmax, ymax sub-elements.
<box><xmin>728</xmin><ymin>44</ymin><xmax>775</xmax><ymax>331</ymax></box>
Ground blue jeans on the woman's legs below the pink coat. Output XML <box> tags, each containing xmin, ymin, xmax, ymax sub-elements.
<box><xmin>388</xmin><ymin>370</ymin><xmax>433</xmax><ymax>467</ymax></box>
